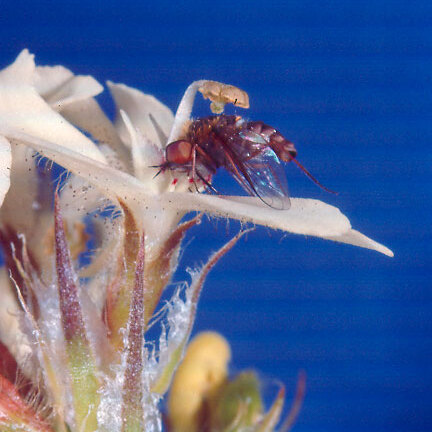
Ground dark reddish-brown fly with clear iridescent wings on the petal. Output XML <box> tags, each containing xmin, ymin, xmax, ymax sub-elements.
<box><xmin>160</xmin><ymin>114</ymin><xmax>332</xmax><ymax>210</ymax></box>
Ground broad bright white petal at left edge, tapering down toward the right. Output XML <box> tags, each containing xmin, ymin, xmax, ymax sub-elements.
<box><xmin>0</xmin><ymin>51</ymin><xmax>104</xmax><ymax>162</ymax></box>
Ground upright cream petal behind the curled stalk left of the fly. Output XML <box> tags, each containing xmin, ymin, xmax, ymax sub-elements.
<box><xmin>107</xmin><ymin>81</ymin><xmax>174</xmax><ymax>147</ymax></box>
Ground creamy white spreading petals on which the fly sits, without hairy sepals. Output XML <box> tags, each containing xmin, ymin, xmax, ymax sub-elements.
<box><xmin>0</xmin><ymin>51</ymin><xmax>393</xmax><ymax>256</ymax></box>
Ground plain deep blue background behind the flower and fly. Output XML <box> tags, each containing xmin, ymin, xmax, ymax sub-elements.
<box><xmin>0</xmin><ymin>0</ymin><xmax>432</xmax><ymax>432</ymax></box>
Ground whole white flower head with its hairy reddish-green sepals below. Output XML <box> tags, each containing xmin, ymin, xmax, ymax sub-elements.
<box><xmin>0</xmin><ymin>50</ymin><xmax>393</xmax><ymax>432</ymax></box>
